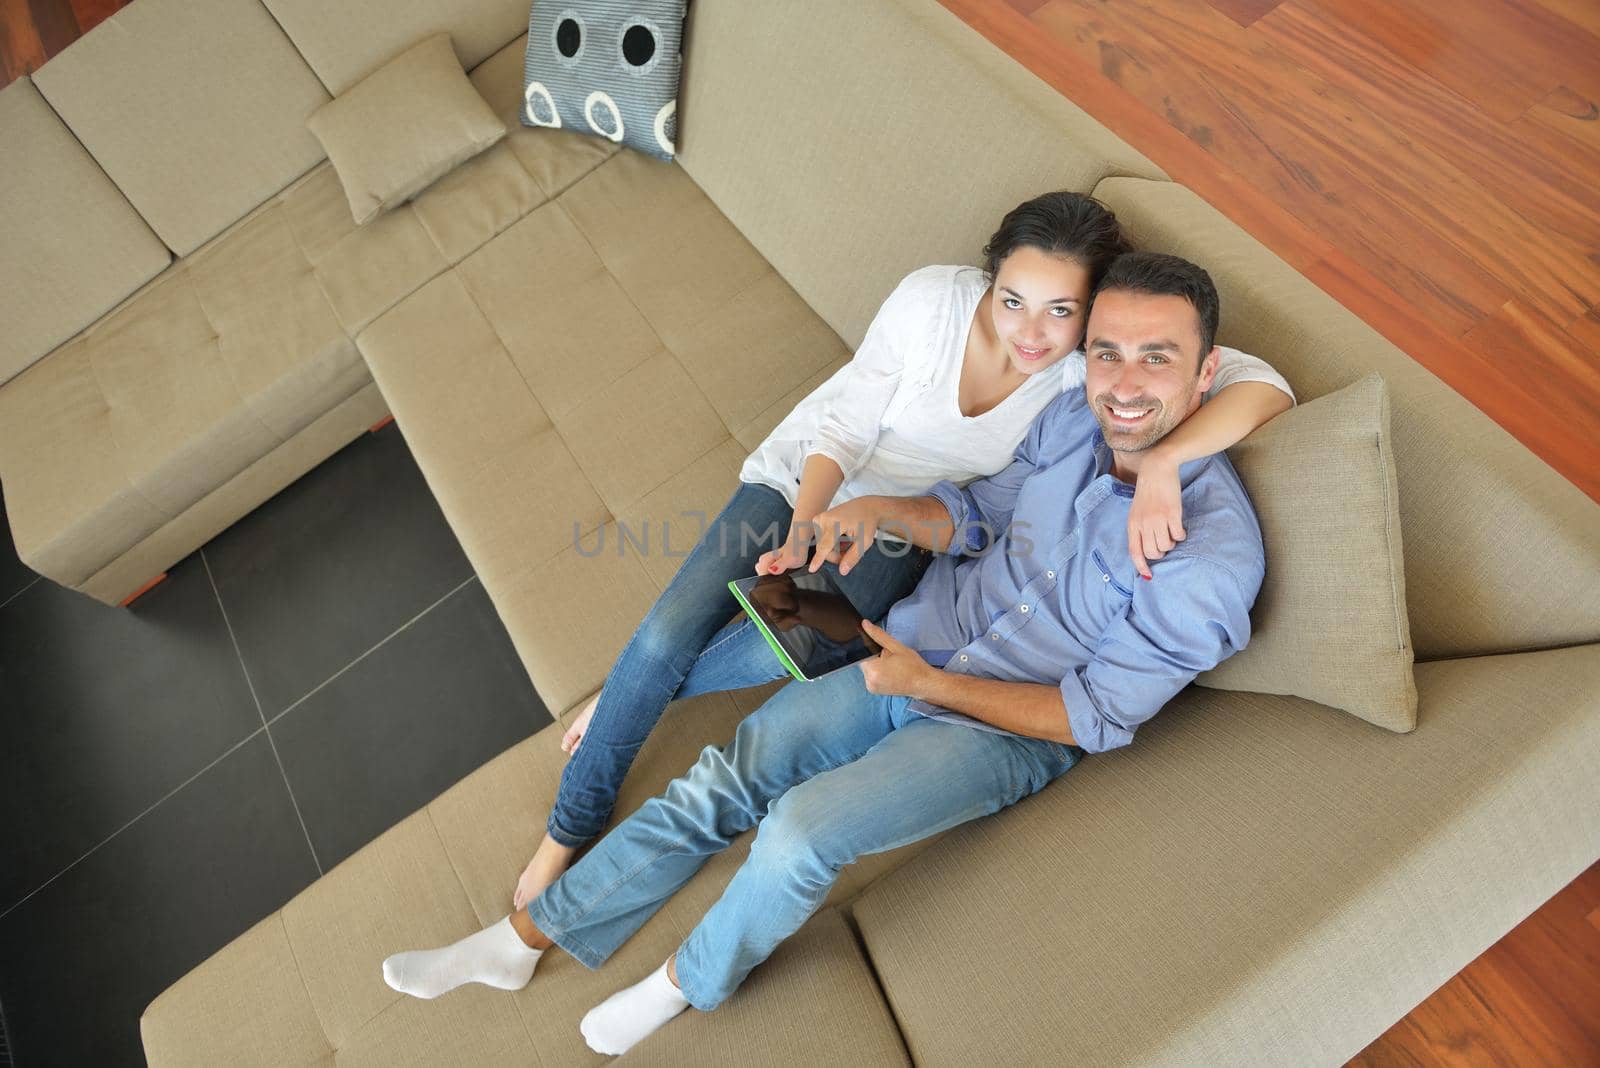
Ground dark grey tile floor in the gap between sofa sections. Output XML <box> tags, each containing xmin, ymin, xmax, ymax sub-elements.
<box><xmin>0</xmin><ymin>424</ymin><xmax>550</xmax><ymax>1066</ymax></box>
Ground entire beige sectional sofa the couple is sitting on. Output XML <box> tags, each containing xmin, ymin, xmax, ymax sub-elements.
<box><xmin>0</xmin><ymin>0</ymin><xmax>1600</xmax><ymax>1065</ymax></box>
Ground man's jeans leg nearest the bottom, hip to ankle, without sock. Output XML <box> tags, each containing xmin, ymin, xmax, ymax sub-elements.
<box><xmin>662</xmin><ymin>711</ymin><xmax>1082</xmax><ymax>1010</ymax></box>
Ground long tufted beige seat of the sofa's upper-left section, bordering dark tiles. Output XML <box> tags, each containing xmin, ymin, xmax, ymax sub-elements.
<box><xmin>0</xmin><ymin>33</ymin><xmax>613</xmax><ymax>603</ymax></box>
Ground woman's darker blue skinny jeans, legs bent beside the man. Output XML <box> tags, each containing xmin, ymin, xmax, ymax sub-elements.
<box><xmin>546</xmin><ymin>483</ymin><xmax>930</xmax><ymax>846</ymax></box>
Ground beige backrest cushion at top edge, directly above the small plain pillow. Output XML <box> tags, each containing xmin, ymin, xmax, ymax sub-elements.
<box><xmin>264</xmin><ymin>0</ymin><xmax>528</xmax><ymax>96</ymax></box>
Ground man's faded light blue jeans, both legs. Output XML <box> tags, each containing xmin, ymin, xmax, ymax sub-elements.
<box><xmin>528</xmin><ymin>664</ymin><xmax>1083</xmax><ymax>1010</ymax></box>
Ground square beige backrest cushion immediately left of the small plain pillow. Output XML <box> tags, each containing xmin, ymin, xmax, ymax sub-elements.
<box><xmin>34</xmin><ymin>0</ymin><xmax>328</xmax><ymax>256</ymax></box>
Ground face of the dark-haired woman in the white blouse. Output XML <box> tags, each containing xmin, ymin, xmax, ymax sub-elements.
<box><xmin>989</xmin><ymin>246</ymin><xmax>1090</xmax><ymax>374</ymax></box>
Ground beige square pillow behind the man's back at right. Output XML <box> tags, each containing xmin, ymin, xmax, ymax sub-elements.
<box><xmin>1195</xmin><ymin>374</ymin><xmax>1416</xmax><ymax>732</ymax></box>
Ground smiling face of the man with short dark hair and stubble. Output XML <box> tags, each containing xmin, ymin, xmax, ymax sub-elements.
<box><xmin>1083</xmin><ymin>289</ymin><xmax>1218</xmax><ymax>476</ymax></box>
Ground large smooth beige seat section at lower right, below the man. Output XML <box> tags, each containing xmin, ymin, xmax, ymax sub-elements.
<box><xmin>853</xmin><ymin>646</ymin><xmax>1600</xmax><ymax>1065</ymax></box>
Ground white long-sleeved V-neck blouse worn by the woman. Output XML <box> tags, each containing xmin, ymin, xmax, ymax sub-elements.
<box><xmin>739</xmin><ymin>267</ymin><xmax>1294</xmax><ymax>507</ymax></box>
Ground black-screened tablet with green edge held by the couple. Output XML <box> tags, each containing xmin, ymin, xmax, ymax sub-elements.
<box><xmin>728</xmin><ymin>568</ymin><xmax>880</xmax><ymax>683</ymax></box>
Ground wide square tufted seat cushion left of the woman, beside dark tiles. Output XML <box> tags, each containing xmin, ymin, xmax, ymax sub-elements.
<box><xmin>357</xmin><ymin>154</ymin><xmax>845</xmax><ymax>708</ymax></box>
